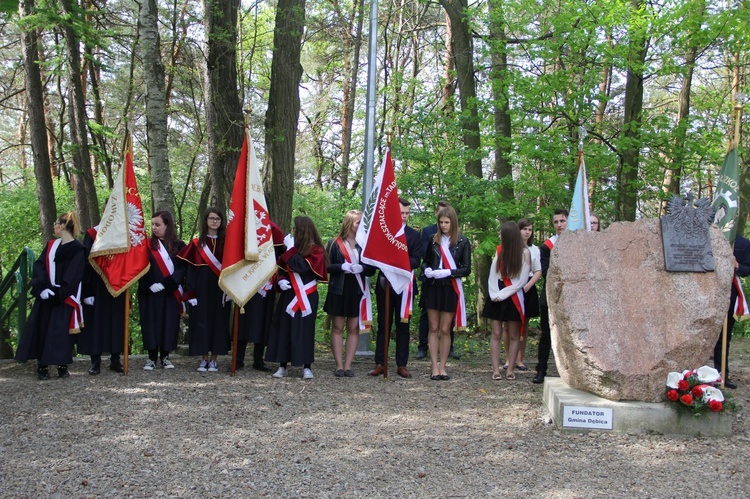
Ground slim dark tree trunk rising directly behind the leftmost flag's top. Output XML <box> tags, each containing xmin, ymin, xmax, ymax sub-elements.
<box><xmin>60</xmin><ymin>0</ymin><xmax>99</xmax><ymax>227</ymax></box>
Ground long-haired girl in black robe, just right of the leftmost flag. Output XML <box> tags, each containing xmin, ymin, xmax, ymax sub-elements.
<box><xmin>138</xmin><ymin>211</ymin><xmax>185</xmax><ymax>371</ymax></box>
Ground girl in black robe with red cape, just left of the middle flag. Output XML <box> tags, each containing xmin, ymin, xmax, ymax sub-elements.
<box><xmin>177</xmin><ymin>208</ymin><xmax>232</xmax><ymax>372</ymax></box>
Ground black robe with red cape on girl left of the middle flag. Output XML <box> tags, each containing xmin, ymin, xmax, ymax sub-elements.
<box><xmin>178</xmin><ymin>238</ymin><xmax>232</xmax><ymax>356</ymax></box>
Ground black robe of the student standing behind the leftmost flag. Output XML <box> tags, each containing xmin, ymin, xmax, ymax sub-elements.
<box><xmin>77</xmin><ymin>229</ymin><xmax>130</xmax><ymax>355</ymax></box>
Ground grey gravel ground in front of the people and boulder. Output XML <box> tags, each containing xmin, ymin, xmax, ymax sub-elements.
<box><xmin>0</xmin><ymin>339</ymin><xmax>750</xmax><ymax>498</ymax></box>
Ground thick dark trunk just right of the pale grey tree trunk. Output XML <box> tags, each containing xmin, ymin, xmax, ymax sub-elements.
<box><xmin>203</xmin><ymin>0</ymin><xmax>245</xmax><ymax>210</ymax></box>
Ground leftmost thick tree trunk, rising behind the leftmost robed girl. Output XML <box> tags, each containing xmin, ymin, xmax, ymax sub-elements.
<box><xmin>18</xmin><ymin>0</ymin><xmax>57</xmax><ymax>241</ymax></box>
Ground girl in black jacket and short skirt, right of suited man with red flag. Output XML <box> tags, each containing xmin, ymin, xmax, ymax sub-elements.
<box><xmin>422</xmin><ymin>206</ymin><xmax>471</xmax><ymax>381</ymax></box>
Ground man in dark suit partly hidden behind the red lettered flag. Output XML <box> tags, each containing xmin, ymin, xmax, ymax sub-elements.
<box><xmin>370</xmin><ymin>198</ymin><xmax>424</xmax><ymax>378</ymax></box>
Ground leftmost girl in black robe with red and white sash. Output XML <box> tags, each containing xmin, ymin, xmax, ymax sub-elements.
<box><xmin>16</xmin><ymin>211</ymin><xmax>86</xmax><ymax>379</ymax></box>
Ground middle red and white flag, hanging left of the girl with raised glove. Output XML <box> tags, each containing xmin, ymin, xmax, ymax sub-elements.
<box><xmin>219</xmin><ymin>129</ymin><xmax>276</xmax><ymax>307</ymax></box>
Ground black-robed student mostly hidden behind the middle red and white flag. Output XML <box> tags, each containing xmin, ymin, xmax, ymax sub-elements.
<box><xmin>237</xmin><ymin>222</ymin><xmax>286</xmax><ymax>372</ymax></box>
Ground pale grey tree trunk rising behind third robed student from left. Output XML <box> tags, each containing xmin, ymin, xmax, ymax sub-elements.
<box><xmin>139</xmin><ymin>0</ymin><xmax>175</xmax><ymax>213</ymax></box>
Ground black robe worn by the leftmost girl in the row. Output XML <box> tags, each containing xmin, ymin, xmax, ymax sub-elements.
<box><xmin>16</xmin><ymin>239</ymin><xmax>86</xmax><ymax>366</ymax></box>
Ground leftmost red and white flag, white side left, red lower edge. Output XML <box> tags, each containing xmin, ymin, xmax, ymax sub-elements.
<box><xmin>89</xmin><ymin>140</ymin><xmax>150</xmax><ymax>296</ymax></box>
